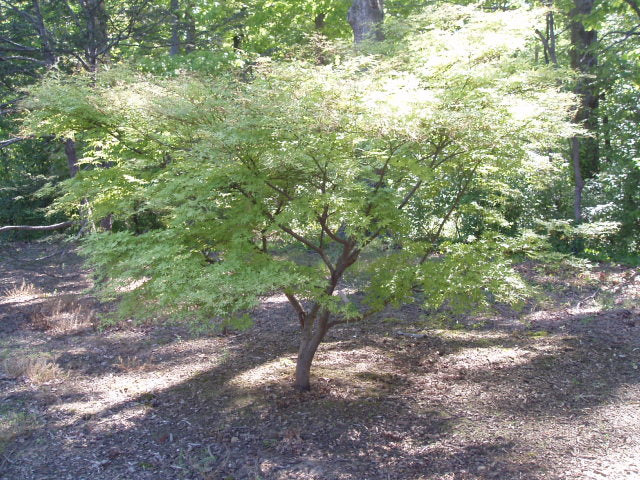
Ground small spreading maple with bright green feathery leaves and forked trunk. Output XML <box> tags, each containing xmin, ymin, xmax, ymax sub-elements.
<box><xmin>24</xmin><ymin>1</ymin><xmax>573</xmax><ymax>390</ymax></box>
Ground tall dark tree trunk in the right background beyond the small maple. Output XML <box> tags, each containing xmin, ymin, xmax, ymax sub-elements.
<box><xmin>569</xmin><ymin>0</ymin><xmax>599</xmax><ymax>223</ymax></box>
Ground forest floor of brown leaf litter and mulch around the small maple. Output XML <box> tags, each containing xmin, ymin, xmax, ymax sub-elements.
<box><xmin>0</xmin><ymin>243</ymin><xmax>640</xmax><ymax>480</ymax></box>
